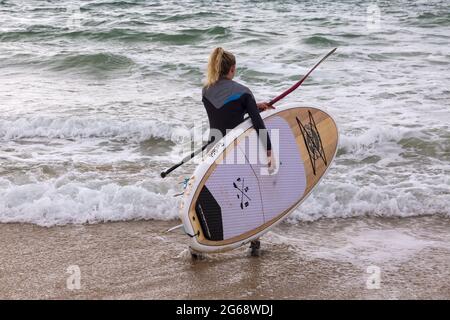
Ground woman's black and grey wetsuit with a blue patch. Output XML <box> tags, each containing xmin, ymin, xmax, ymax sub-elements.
<box><xmin>202</xmin><ymin>79</ymin><xmax>272</xmax><ymax>150</ymax></box>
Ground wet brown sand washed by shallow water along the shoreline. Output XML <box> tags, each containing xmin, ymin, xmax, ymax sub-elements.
<box><xmin>0</xmin><ymin>217</ymin><xmax>450</xmax><ymax>299</ymax></box>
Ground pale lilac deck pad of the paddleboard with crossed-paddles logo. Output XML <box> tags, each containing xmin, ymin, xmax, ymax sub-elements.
<box><xmin>205</xmin><ymin>116</ymin><xmax>306</xmax><ymax>240</ymax></box>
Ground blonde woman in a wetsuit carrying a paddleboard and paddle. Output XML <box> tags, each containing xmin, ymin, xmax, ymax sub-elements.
<box><xmin>202</xmin><ymin>48</ymin><xmax>273</xmax><ymax>255</ymax></box>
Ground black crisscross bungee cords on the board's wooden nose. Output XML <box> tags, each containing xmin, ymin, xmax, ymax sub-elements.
<box><xmin>295</xmin><ymin>110</ymin><xmax>328</xmax><ymax>175</ymax></box>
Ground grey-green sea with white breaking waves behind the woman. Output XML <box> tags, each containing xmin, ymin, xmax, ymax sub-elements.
<box><xmin>0</xmin><ymin>0</ymin><xmax>450</xmax><ymax>226</ymax></box>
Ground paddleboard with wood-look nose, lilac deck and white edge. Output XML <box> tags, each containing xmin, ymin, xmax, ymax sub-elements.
<box><xmin>180</xmin><ymin>107</ymin><xmax>338</xmax><ymax>253</ymax></box>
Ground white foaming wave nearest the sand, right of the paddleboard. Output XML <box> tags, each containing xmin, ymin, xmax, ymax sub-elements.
<box><xmin>289</xmin><ymin>175</ymin><xmax>450</xmax><ymax>223</ymax></box>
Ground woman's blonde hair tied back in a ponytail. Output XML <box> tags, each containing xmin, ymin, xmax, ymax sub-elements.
<box><xmin>205</xmin><ymin>47</ymin><xmax>236</xmax><ymax>87</ymax></box>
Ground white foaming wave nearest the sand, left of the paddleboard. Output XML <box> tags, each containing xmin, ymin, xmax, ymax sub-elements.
<box><xmin>0</xmin><ymin>177</ymin><xmax>178</xmax><ymax>227</ymax></box>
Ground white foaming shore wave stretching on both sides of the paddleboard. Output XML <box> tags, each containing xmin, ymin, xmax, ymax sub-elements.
<box><xmin>0</xmin><ymin>171</ymin><xmax>450</xmax><ymax>227</ymax></box>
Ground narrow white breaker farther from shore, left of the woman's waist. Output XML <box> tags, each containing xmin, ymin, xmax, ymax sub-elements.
<box><xmin>0</xmin><ymin>117</ymin><xmax>190</xmax><ymax>143</ymax></box>
